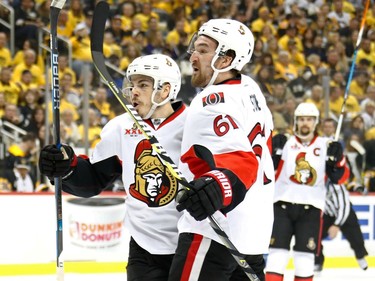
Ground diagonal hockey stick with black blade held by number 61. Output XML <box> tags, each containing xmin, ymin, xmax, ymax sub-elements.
<box><xmin>90</xmin><ymin>1</ymin><xmax>260</xmax><ymax>281</ymax></box>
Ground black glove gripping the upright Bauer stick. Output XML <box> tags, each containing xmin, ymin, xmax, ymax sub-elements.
<box><xmin>39</xmin><ymin>144</ymin><xmax>77</xmax><ymax>177</ymax></box>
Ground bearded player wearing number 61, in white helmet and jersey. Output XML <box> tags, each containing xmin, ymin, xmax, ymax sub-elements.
<box><xmin>169</xmin><ymin>19</ymin><xmax>274</xmax><ymax>281</ymax></box>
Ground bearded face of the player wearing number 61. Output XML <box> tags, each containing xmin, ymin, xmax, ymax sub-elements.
<box><xmin>190</xmin><ymin>36</ymin><xmax>217</xmax><ymax>87</ymax></box>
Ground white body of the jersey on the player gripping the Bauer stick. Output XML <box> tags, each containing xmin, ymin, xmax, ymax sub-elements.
<box><xmin>90</xmin><ymin>104</ymin><xmax>186</xmax><ymax>255</ymax></box>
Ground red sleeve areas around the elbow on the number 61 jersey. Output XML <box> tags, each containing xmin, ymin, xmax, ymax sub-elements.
<box><xmin>181</xmin><ymin>147</ymin><xmax>258</xmax><ymax>189</ymax></box>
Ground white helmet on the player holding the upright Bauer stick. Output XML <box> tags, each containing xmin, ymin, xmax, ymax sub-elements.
<box><xmin>123</xmin><ymin>54</ymin><xmax>181</xmax><ymax>119</ymax></box>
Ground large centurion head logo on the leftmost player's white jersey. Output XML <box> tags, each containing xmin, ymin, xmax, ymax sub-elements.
<box><xmin>129</xmin><ymin>140</ymin><xmax>178</xmax><ymax>207</ymax></box>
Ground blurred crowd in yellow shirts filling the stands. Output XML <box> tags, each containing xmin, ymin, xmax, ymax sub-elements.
<box><xmin>0</xmin><ymin>0</ymin><xmax>375</xmax><ymax>191</ymax></box>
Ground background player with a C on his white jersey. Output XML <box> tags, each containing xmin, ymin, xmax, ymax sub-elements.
<box><xmin>266</xmin><ymin>103</ymin><xmax>349</xmax><ymax>281</ymax></box>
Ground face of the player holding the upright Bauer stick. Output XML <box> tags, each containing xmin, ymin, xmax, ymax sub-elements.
<box><xmin>125</xmin><ymin>75</ymin><xmax>154</xmax><ymax>118</ymax></box>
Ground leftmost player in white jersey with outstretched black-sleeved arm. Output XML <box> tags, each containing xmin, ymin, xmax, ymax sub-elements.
<box><xmin>39</xmin><ymin>54</ymin><xmax>186</xmax><ymax>281</ymax></box>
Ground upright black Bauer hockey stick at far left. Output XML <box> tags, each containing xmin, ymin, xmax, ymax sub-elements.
<box><xmin>50</xmin><ymin>0</ymin><xmax>66</xmax><ymax>281</ymax></box>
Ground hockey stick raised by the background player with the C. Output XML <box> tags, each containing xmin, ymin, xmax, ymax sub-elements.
<box><xmin>335</xmin><ymin>0</ymin><xmax>370</xmax><ymax>141</ymax></box>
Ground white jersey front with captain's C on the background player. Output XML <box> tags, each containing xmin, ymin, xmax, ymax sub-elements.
<box><xmin>275</xmin><ymin>136</ymin><xmax>329</xmax><ymax>210</ymax></box>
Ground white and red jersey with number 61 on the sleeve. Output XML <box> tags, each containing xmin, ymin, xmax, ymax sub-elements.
<box><xmin>179</xmin><ymin>75</ymin><xmax>274</xmax><ymax>254</ymax></box>
